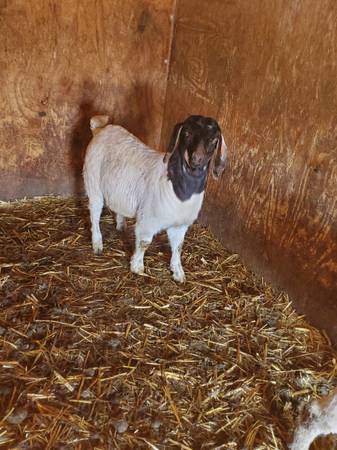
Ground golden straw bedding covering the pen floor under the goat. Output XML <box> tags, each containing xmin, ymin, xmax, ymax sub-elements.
<box><xmin>0</xmin><ymin>197</ymin><xmax>337</xmax><ymax>450</ymax></box>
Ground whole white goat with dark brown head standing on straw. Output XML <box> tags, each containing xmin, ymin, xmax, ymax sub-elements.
<box><xmin>83</xmin><ymin>116</ymin><xmax>227</xmax><ymax>282</ymax></box>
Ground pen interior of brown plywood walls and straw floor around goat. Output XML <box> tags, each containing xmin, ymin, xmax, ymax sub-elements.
<box><xmin>0</xmin><ymin>0</ymin><xmax>337</xmax><ymax>450</ymax></box>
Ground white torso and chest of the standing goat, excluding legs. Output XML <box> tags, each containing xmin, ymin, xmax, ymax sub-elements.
<box><xmin>84</xmin><ymin>125</ymin><xmax>203</xmax><ymax>227</ymax></box>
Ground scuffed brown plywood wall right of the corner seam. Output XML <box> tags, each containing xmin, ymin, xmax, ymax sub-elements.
<box><xmin>161</xmin><ymin>0</ymin><xmax>337</xmax><ymax>342</ymax></box>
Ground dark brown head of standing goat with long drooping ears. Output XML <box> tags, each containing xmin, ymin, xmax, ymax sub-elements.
<box><xmin>164</xmin><ymin>116</ymin><xmax>227</xmax><ymax>179</ymax></box>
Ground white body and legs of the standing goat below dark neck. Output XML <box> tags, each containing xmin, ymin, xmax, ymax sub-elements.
<box><xmin>83</xmin><ymin>125</ymin><xmax>204</xmax><ymax>281</ymax></box>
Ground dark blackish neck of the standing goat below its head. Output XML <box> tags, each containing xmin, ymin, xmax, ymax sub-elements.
<box><xmin>167</xmin><ymin>152</ymin><xmax>208</xmax><ymax>202</ymax></box>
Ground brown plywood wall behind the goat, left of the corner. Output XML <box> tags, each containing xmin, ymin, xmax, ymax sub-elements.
<box><xmin>0</xmin><ymin>0</ymin><xmax>173</xmax><ymax>199</ymax></box>
